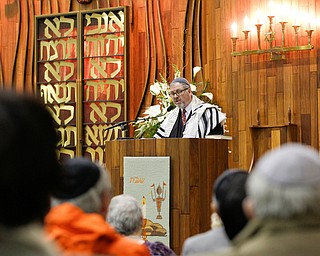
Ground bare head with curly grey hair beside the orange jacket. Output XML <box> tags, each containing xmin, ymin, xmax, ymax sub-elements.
<box><xmin>107</xmin><ymin>195</ymin><xmax>143</xmax><ymax>236</ymax></box>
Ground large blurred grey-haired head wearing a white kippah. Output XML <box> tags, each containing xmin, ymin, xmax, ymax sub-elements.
<box><xmin>245</xmin><ymin>143</ymin><xmax>320</xmax><ymax>219</ymax></box>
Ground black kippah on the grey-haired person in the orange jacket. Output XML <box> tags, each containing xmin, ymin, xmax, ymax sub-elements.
<box><xmin>54</xmin><ymin>157</ymin><xmax>100</xmax><ymax>199</ymax></box>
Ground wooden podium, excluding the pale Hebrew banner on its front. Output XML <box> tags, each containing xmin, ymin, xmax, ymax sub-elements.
<box><xmin>105</xmin><ymin>138</ymin><xmax>228</xmax><ymax>255</ymax></box>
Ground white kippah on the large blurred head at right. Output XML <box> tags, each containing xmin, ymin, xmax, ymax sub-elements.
<box><xmin>252</xmin><ymin>143</ymin><xmax>320</xmax><ymax>186</ymax></box>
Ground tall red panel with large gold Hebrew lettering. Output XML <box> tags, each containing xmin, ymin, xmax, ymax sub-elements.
<box><xmin>35</xmin><ymin>8</ymin><xmax>127</xmax><ymax>162</ymax></box>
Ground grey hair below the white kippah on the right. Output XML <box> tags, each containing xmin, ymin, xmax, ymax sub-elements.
<box><xmin>247</xmin><ymin>171</ymin><xmax>320</xmax><ymax>218</ymax></box>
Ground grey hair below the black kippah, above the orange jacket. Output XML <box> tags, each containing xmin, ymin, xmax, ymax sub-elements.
<box><xmin>51</xmin><ymin>164</ymin><xmax>112</xmax><ymax>214</ymax></box>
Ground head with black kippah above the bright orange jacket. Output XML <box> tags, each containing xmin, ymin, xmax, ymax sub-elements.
<box><xmin>52</xmin><ymin>157</ymin><xmax>111</xmax><ymax>216</ymax></box>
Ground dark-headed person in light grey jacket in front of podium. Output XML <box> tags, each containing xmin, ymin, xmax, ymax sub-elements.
<box><xmin>182</xmin><ymin>169</ymin><xmax>248</xmax><ymax>256</ymax></box>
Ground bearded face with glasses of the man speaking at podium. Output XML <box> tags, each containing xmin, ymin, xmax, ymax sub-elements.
<box><xmin>170</xmin><ymin>83</ymin><xmax>192</xmax><ymax>108</ymax></box>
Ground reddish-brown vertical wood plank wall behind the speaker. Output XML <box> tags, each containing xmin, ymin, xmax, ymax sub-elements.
<box><xmin>0</xmin><ymin>0</ymin><xmax>320</xmax><ymax>240</ymax></box>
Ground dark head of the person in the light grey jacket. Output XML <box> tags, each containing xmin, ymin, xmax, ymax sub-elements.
<box><xmin>213</xmin><ymin>169</ymin><xmax>248</xmax><ymax>240</ymax></box>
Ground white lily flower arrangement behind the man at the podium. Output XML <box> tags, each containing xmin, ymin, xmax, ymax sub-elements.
<box><xmin>133</xmin><ymin>65</ymin><xmax>213</xmax><ymax>138</ymax></box>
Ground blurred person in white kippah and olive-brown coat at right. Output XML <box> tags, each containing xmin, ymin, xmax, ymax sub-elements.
<box><xmin>214</xmin><ymin>143</ymin><xmax>320</xmax><ymax>256</ymax></box>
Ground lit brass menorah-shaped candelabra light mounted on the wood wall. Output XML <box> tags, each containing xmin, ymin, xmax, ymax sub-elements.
<box><xmin>231</xmin><ymin>8</ymin><xmax>313</xmax><ymax>60</ymax></box>
